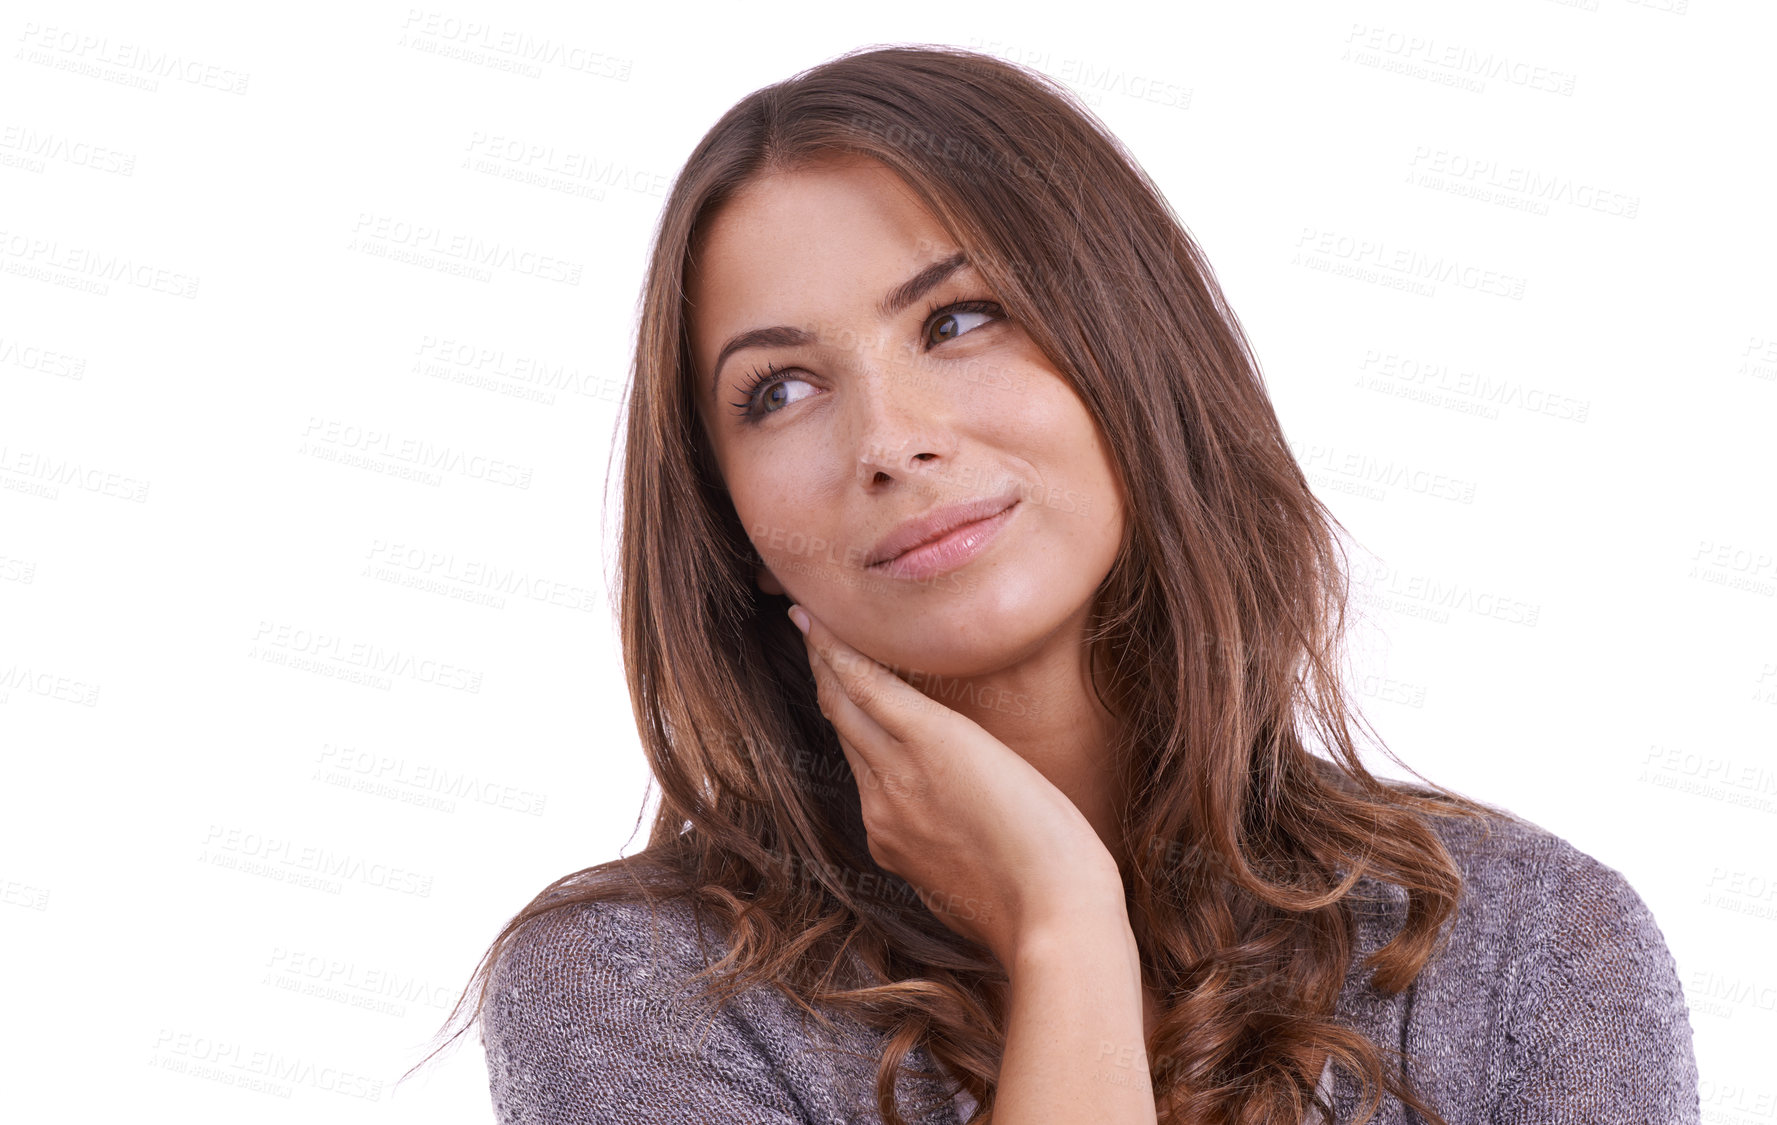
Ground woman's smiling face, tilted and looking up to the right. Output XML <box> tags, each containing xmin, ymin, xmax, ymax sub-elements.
<box><xmin>688</xmin><ymin>160</ymin><xmax>1123</xmax><ymax>682</ymax></box>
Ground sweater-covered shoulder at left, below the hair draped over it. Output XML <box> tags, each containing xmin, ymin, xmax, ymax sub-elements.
<box><xmin>482</xmin><ymin>898</ymin><xmax>966</xmax><ymax>1125</ymax></box>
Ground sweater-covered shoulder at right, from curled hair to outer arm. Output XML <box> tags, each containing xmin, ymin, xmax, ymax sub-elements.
<box><xmin>1372</xmin><ymin>810</ymin><xmax>1697</xmax><ymax>1125</ymax></box>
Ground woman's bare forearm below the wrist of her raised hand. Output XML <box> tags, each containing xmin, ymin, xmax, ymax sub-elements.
<box><xmin>993</xmin><ymin>910</ymin><xmax>1155</xmax><ymax>1125</ymax></box>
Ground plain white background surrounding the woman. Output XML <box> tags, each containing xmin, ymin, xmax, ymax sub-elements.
<box><xmin>0</xmin><ymin>0</ymin><xmax>1777</xmax><ymax>1123</ymax></box>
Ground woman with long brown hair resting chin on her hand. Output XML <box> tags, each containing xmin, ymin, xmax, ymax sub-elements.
<box><xmin>422</xmin><ymin>48</ymin><xmax>1697</xmax><ymax>1125</ymax></box>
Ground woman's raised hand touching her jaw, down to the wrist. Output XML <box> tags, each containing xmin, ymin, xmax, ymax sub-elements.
<box><xmin>791</xmin><ymin>606</ymin><xmax>1125</xmax><ymax>970</ymax></box>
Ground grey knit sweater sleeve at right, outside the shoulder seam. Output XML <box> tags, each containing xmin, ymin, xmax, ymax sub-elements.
<box><xmin>1493</xmin><ymin>844</ymin><xmax>1699</xmax><ymax>1125</ymax></box>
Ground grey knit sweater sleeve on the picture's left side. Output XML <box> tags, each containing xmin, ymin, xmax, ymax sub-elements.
<box><xmin>482</xmin><ymin>903</ymin><xmax>807</xmax><ymax>1125</ymax></box>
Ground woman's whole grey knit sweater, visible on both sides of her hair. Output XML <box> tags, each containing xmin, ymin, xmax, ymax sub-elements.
<box><xmin>482</xmin><ymin>819</ymin><xmax>1699</xmax><ymax>1125</ymax></box>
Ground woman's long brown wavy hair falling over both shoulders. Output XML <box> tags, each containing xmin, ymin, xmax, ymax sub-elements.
<box><xmin>408</xmin><ymin>46</ymin><xmax>1502</xmax><ymax>1125</ymax></box>
